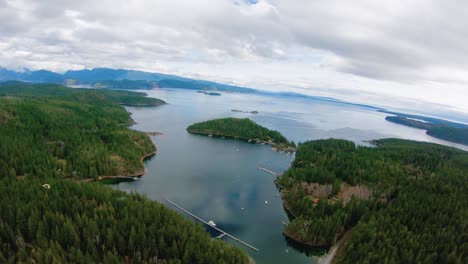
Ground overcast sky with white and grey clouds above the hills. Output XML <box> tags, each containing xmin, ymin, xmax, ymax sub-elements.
<box><xmin>0</xmin><ymin>0</ymin><xmax>468</xmax><ymax>114</ymax></box>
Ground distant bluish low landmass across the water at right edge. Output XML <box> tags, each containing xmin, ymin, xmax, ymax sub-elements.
<box><xmin>385</xmin><ymin>116</ymin><xmax>468</xmax><ymax>146</ymax></box>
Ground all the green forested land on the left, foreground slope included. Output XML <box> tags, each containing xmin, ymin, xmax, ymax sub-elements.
<box><xmin>0</xmin><ymin>83</ymin><xmax>249</xmax><ymax>264</ymax></box>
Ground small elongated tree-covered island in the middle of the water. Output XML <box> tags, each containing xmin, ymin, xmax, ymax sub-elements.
<box><xmin>187</xmin><ymin>117</ymin><xmax>295</xmax><ymax>152</ymax></box>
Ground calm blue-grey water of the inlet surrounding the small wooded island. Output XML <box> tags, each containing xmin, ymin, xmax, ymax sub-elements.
<box><xmin>111</xmin><ymin>90</ymin><xmax>466</xmax><ymax>263</ymax></box>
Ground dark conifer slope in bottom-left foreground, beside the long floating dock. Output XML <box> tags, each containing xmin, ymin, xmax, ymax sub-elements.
<box><xmin>0</xmin><ymin>177</ymin><xmax>248</xmax><ymax>264</ymax></box>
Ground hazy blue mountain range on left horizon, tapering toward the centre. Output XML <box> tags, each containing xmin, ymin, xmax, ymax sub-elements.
<box><xmin>0</xmin><ymin>67</ymin><xmax>256</xmax><ymax>93</ymax></box>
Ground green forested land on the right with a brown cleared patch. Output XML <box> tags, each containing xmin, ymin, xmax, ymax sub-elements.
<box><xmin>276</xmin><ymin>139</ymin><xmax>468</xmax><ymax>263</ymax></box>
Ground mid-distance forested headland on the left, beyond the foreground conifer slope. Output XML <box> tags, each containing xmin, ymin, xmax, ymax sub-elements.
<box><xmin>0</xmin><ymin>84</ymin><xmax>162</xmax><ymax>178</ymax></box>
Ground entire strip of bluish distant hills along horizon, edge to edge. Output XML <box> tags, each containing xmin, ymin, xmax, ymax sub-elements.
<box><xmin>0</xmin><ymin>67</ymin><xmax>468</xmax><ymax>145</ymax></box>
